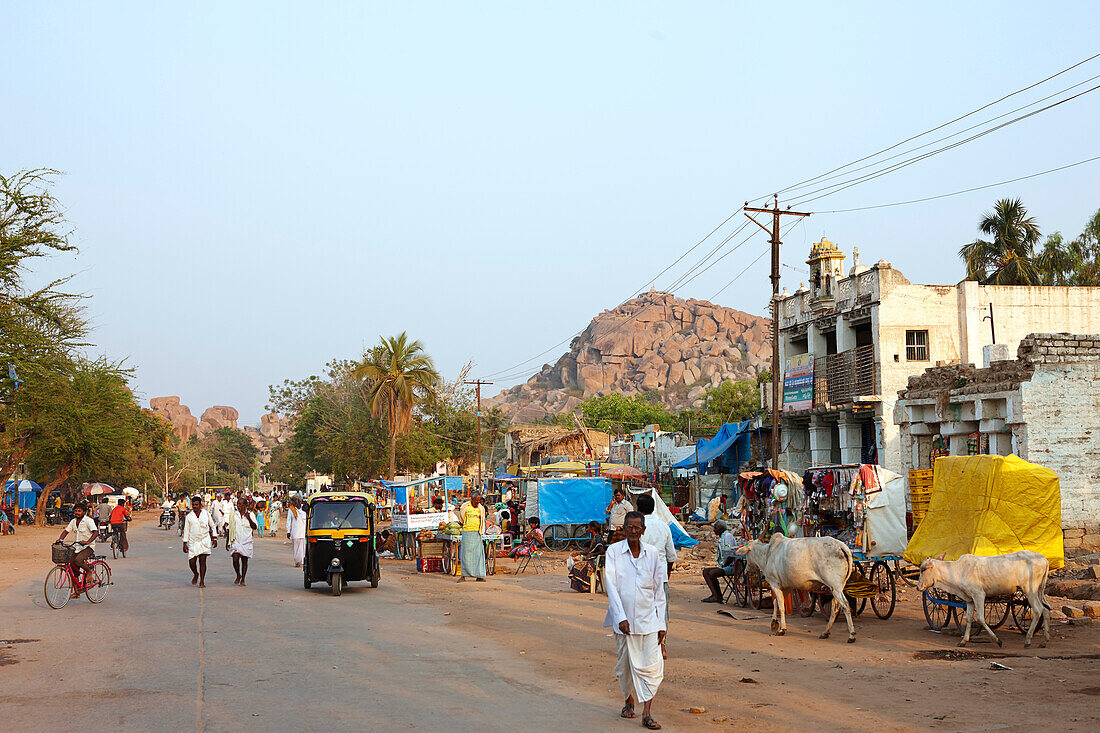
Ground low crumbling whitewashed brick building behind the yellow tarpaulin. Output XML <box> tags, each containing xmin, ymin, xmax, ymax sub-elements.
<box><xmin>894</xmin><ymin>333</ymin><xmax>1100</xmax><ymax>549</ymax></box>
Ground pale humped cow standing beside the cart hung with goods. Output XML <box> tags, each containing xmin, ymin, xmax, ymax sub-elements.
<box><xmin>738</xmin><ymin>532</ymin><xmax>856</xmax><ymax>644</ymax></box>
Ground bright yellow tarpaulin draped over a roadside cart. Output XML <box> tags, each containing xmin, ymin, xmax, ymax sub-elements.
<box><xmin>904</xmin><ymin>456</ymin><xmax>1066</xmax><ymax>570</ymax></box>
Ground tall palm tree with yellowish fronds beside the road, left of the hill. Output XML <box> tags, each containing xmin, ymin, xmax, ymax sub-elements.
<box><xmin>352</xmin><ymin>331</ymin><xmax>440</xmax><ymax>480</ymax></box>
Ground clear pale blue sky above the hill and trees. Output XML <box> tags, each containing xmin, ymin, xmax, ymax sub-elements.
<box><xmin>0</xmin><ymin>0</ymin><xmax>1100</xmax><ymax>424</ymax></box>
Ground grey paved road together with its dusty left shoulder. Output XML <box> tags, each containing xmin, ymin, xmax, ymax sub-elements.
<box><xmin>0</xmin><ymin>523</ymin><xmax>608</xmax><ymax>731</ymax></box>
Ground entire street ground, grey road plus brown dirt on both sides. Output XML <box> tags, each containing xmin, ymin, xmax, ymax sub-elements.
<box><xmin>0</xmin><ymin>515</ymin><xmax>1100</xmax><ymax>731</ymax></box>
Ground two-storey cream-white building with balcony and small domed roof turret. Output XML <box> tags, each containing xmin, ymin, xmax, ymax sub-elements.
<box><xmin>779</xmin><ymin>238</ymin><xmax>1100</xmax><ymax>471</ymax></box>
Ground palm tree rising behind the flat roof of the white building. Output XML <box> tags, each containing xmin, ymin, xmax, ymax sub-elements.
<box><xmin>959</xmin><ymin>198</ymin><xmax>1042</xmax><ymax>285</ymax></box>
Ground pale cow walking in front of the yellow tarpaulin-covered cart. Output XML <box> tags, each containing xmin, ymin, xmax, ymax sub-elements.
<box><xmin>916</xmin><ymin>550</ymin><xmax>1051</xmax><ymax>647</ymax></box>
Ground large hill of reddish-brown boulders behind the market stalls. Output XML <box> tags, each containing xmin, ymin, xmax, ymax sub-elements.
<box><xmin>485</xmin><ymin>291</ymin><xmax>771</xmax><ymax>423</ymax></box>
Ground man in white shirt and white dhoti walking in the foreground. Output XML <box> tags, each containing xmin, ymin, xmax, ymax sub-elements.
<box><xmin>604</xmin><ymin>512</ymin><xmax>668</xmax><ymax>731</ymax></box>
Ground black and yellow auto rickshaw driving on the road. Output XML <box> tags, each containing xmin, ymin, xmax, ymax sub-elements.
<box><xmin>301</xmin><ymin>492</ymin><xmax>378</xmax><ymax>595</ymax></box>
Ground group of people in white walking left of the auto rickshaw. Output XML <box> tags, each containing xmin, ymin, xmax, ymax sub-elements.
<box><xmin>180</xmin><ymin>491</ymin><xmax>306</xmax><ymax>588</ymax></box>
